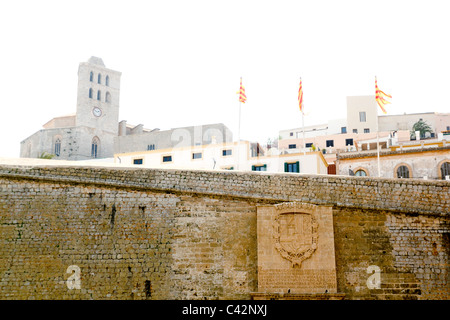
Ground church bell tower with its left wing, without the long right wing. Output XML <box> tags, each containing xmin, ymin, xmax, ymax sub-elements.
<box><xmin>20</xmin><ymin>57</ymin><xmax>122</xmax><ymax>160</ymax></box>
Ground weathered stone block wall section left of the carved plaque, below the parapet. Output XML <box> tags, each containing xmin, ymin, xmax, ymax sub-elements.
<box><xmin>0</xmin><ymin>175</ymin><xmax>256</xmax><ymax>299</ymax></box>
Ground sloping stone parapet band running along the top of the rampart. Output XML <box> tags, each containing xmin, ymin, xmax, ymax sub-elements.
<box><xmin>0</xmin><ymin>165</ymin><xmax>450</xmax><ymax>216</ymax></box>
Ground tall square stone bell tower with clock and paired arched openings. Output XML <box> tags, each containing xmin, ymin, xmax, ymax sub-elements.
<box><xmin>75</xmin><ymin>57</ymin><xmax>122</xmax><ymax>135</ymax></box>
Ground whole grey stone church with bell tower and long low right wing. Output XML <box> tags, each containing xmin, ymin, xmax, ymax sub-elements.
<box><xmin>20</xmin><ymin>57</ymin><xmax>232</xmax><ymax>160</ymax></box>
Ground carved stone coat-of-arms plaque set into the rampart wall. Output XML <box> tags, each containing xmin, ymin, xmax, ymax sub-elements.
<box><xmin>253</xmin><ymin>202</ymin><xmax>337</xmax><ymax>294</ymax></box>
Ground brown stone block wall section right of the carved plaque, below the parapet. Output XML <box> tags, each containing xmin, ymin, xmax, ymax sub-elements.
<box><xmin>333</xmin><ymin>207</ymin><xmax>450</xmax><ymax>300</ymax></box>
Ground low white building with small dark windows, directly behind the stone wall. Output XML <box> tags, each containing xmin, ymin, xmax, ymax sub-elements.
<box><xmin>114</xmin><ymin>141</ymin><xmax>328</xmax><ymax>174</ymax></box>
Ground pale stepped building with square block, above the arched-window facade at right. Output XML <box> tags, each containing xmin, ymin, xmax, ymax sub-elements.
<box><xmin>278</xmin><ymin>96</ymin><xmax>450</xmax><ymax>164</ymax></box>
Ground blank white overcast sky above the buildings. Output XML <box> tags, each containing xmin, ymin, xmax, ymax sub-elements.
<box><xmin>0</xmin><ymin>0</ymin><xmax>450</xmax><ymax>157</ymax></box>
